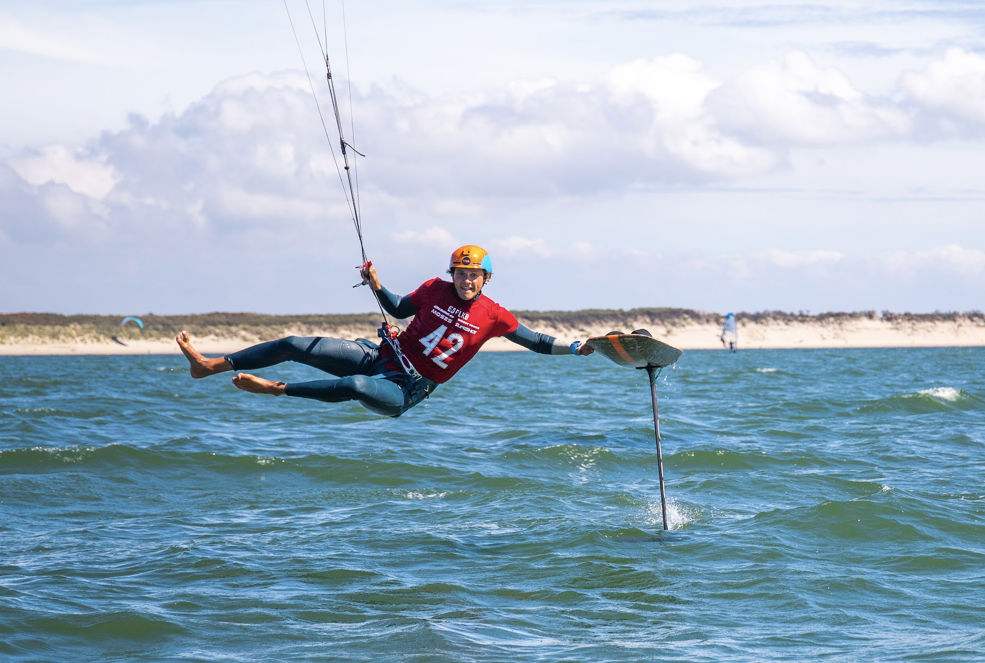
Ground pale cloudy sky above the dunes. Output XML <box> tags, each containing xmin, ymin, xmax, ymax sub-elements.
<box><xmin>0</xmin><ymin>0</ymin><xmax>985</xmax><ymax>314</ymax></box>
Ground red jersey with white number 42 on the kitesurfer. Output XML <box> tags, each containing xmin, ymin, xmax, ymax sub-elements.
<box><xmin>398</xmin><ymin>278</ymin><xmax>520</xmax><ymax>384</ymax></box>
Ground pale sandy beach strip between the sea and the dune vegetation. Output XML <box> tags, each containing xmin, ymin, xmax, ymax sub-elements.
<box><xmin>0</xmin><ymin>314</ymin><xmax>985</xmax><ymax>356</ymax></box>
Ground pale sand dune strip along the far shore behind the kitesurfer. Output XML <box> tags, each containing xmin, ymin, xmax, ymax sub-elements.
<box><xmin>0</xmin><ymin>309</ymin><xmax>985</xmax><ymax>355</ymax></box>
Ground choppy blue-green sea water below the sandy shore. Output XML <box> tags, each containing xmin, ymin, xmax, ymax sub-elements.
<box><xmin>0</xmin><ymin>348</ymin><xmax>985</xmax><ymax>662</ymax></box>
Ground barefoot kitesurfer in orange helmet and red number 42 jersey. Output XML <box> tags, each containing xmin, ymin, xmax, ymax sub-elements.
<box><xmin>176</xmin><ymin>244</ymin><xmax>592</xmax><ymax>417</ymax></box>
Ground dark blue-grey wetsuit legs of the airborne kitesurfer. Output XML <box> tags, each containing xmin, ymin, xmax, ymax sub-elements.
<box><xmin>226</xmin><ymin>336</ymin><xmax>434</xmax><ymax>417</ymax></box>
